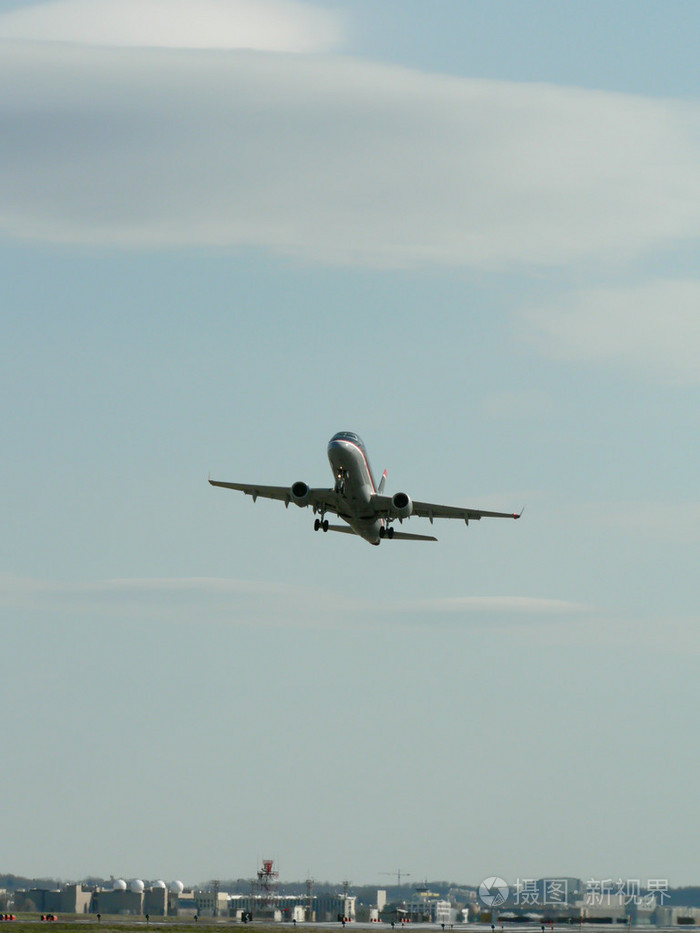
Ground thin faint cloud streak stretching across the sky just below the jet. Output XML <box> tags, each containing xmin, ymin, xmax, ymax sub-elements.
<box><xmin>0</xmin><ymin>574</ymin><xmax>700</xmax><ymax>654</ymax></box>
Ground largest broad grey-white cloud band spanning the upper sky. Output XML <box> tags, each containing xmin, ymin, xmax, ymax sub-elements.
<box><xmin>0</xmin><ymin>40</ymin><xmax>700</xmax><ymax>267</ymax></box>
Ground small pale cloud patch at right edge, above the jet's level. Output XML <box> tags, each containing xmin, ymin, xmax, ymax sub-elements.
<box><xmin>522</xmin><ymin>279</ymin><xmax>700</xmax><ymax>384</ymax></box>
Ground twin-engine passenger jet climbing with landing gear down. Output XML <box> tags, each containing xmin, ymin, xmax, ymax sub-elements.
<box><xmin>209</xmin><ymin>431</ymin><xmax>522</xmax><ymax>545</ymax></box>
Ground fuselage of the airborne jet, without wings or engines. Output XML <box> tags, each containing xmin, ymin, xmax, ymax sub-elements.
<box><xmin>328</xmin><ymin>432</ymin><xmax>384</xmax><ymax>544</ymax></box>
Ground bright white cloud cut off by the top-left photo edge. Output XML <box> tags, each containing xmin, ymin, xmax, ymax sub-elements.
<box><xmin>0</xmin><ymin>0</ymin><xmax>341</xmax><ymax>53</ymax></box>
